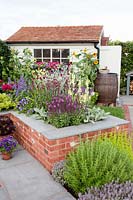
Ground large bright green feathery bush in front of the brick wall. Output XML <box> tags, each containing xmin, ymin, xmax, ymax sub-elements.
<box><xmin>64</xmin><ymin>139</ymin><xmax>133</xmax><ymax>195</ymax></box>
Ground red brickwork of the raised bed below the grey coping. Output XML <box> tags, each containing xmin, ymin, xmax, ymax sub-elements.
<box><xmin>1</xmin><ymin>113</ymin><xmax>128</xmax><ymax>171</ymax></box>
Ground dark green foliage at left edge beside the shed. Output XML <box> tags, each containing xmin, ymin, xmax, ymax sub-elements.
<box><xmin>0</xmin><ymin>40</ymin><xmax>13</xmax><ymax>81</ymax></box>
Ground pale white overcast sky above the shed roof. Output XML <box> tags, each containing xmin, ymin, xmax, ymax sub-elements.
<box><xmin>0</xmin><ymin>0</ymin><xmax>133</xmax><ymax>41</ymax></box>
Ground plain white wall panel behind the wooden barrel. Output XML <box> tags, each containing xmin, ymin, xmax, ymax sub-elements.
<box><xmin>99</xmin><ymin>46</ymin><xmax>122</xmax><ymax>96</ymax></box>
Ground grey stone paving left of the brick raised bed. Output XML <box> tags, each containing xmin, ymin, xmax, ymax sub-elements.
<box><xmin>0</xmin><ymin>150</ymin><xmax>74</xmax><ymax>200</ymax></box>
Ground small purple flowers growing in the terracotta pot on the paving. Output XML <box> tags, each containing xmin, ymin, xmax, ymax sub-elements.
<box><xmin>0</xmin><ymin>136</ymin><xmax>18</xmax><ymax>153</ymax></box>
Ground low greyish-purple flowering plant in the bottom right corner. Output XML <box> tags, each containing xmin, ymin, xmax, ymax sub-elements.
<box><xmin>78</xmin><ymin>181</ymin><xmax>133</xmax><ymax>200</ymax></box>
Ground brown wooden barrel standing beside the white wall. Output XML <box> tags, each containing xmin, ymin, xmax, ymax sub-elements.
<box><xmin>94</xmin><ymin>73</ymin><xmax>118</xmax><ymax>105</ymax></box>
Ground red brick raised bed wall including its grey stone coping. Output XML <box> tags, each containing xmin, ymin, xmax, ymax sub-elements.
<box><xmin>1</xmin><ymin>112</ymin><xmax>129</xmax><ymax>171</ymax></box>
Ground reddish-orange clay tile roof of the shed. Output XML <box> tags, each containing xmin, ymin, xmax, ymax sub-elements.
<box><xmin>6</xmin><ymin>26</ymin><xmax>103</xmax><ymax>43</ymax></box>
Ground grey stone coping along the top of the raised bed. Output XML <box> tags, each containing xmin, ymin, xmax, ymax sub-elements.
<box><xmin>0</xmin><ymin>111</ymin><xmax>129</xmax><ymax>140</ymax></box>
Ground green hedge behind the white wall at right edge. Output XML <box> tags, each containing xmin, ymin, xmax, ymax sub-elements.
<box><xmin>110</xmin><ymin>41</ymin><xmax>133</xmax><ymax>94</ymax></box>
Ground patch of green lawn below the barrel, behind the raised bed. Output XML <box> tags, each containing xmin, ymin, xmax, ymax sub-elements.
<box><xmin>100</xmin><ymin>106</ymin><xmax>125</xmax><ymax>119</ymax></box>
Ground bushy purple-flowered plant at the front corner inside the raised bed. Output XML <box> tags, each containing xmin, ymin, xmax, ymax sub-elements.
<box><xmin>47</xmin><ymin>95</ymin><xmax>84</xmax><ymax>128</ymax></box>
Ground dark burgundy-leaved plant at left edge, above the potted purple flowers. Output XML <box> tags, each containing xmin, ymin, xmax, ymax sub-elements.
<box><xmin>0</xmin><ymin>115</ymin><xmax>15</xmax><ymax>136</ymax></box>
